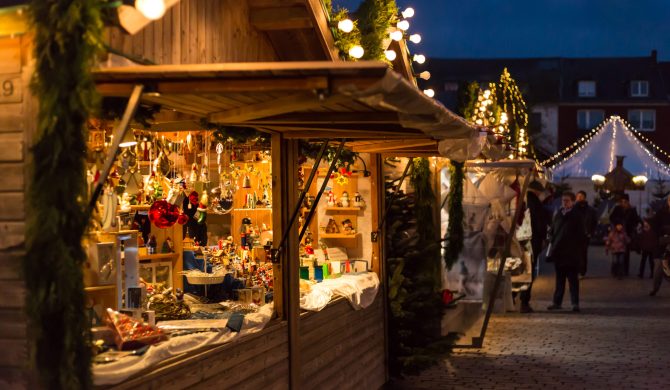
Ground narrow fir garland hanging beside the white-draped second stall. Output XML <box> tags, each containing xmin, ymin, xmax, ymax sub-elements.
<box><xmin>444</xmin><ymin>161</ymin><xmax>464</xmax><ymax>269</ymax></box>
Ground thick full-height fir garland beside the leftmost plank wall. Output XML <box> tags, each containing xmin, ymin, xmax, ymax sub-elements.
<box><xmin>22</xmin><ymin>0</ymin><xmax>102</xmax><ymax>389</ymax></box>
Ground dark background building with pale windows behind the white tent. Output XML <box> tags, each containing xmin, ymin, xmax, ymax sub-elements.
<box><xmin>425</xmin><ymin>50</ymin><xmax>670</xmax><ymax>158</ymax></box>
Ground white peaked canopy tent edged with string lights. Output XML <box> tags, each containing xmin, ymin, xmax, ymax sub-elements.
<box><xmin>549</xmin><ymin>116</ymin><xmax>670</xmax><ymax>180</ymax></box>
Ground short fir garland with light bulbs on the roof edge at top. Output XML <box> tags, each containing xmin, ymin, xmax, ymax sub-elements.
<box><xmin>356</xmin><ymin>0</ymin><xmax>398</xmax><ymax>62</ymax></box>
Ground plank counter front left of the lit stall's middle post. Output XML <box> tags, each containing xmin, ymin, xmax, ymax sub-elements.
<box><xmin>106</xmin><ymin>321</ymin><xmax>288</xmax><ymax>390</ymax></box>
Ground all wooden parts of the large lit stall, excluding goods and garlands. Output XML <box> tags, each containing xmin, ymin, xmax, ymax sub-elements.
<box><xmin>0</xmin><ymin>0</ymin><xmax>484</xmax><ymax>388</ymax></box>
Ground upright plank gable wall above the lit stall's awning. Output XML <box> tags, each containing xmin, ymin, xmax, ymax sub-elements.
<box><xmin>107</xmin><ymin>0</ymin><xmax>278</xmax><ymax>64</ymax></box>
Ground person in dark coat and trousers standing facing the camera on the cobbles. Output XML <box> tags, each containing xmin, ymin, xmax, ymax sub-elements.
<box><xmin>547</xmin><ymin>192</ymin><xmax>586</xmax><ymax>312</ymax></box>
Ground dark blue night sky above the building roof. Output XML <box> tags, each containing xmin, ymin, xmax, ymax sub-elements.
<box><xmin>333</xmin><ymin>0</ymin><xmax>670</xmax><ymax>61</ymax></box>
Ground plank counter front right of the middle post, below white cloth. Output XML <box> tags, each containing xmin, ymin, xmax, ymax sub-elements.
<box><xmin>300</xmin><ymin>295</ymin><xmax>386</xmax><ymax>389</ymax></box>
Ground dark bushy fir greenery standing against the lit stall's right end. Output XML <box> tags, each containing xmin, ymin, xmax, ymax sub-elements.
<box><xmin>386</xmin><ymin>158</ymin><xmax>452</xmax><ymax>376</ymax></box>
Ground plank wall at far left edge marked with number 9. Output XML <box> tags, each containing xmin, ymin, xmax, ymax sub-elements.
<box><xmin>0</xmin><ymin>36</ymin><xmax>36</xmax><ymax>389</ymax></box>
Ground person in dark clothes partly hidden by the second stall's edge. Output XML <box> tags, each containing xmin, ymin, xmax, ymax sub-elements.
<box><xmin>520</xmin><ymin>181</ymin><xmax>551</xmax><ymax>313</ymax></box>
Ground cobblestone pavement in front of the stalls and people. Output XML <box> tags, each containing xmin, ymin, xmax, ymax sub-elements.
<box><xmin>392</xmin><ymin>247</ymin><xmax>670</xmax><ymax>390</ymax></box>
